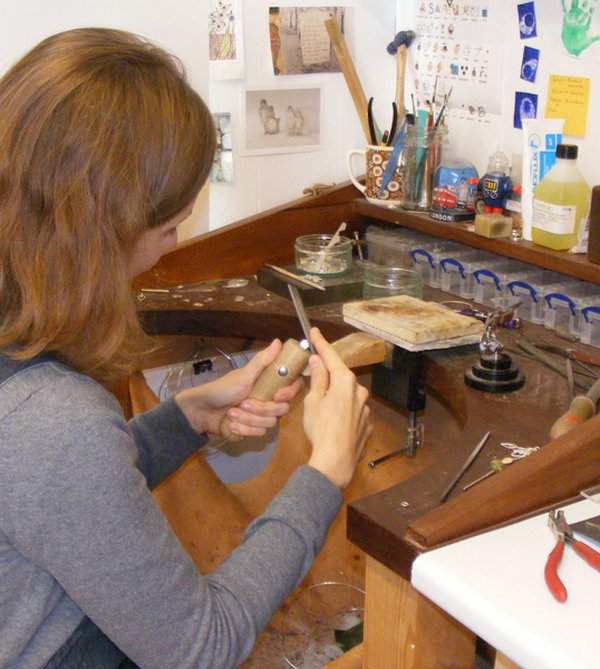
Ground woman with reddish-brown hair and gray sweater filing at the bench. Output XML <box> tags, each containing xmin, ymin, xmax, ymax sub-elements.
<box><xmin>0</xmin><ymin>29</ymin><xmax>371</xmax><ymax>669</ymax></box>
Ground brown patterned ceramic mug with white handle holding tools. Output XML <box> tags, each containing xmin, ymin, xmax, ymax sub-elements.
<box><xmin>347</xmin><ymin>144</ymin><xmax>404</xmax><ymax>206</ymax></box>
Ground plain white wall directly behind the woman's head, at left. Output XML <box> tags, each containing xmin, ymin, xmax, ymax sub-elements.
<box><xmin>0</xmin><ymin>0</ymin><xmax>209</xmax><ymax>237</ymax></box>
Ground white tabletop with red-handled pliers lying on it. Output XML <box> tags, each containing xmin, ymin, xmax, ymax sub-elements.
<box><xmin>411</xmin><ymin>500</ymin><xmax>600</xmax><ymax>669</ymax></box>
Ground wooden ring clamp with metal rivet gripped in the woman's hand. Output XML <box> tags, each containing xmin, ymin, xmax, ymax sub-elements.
<box><xmin>220</xmin><ymin>339</ymin><xmax>310</xmax><ymax>441</ymax></box>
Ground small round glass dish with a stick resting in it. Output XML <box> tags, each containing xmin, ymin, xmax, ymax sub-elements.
<box><xmin>294</xmin><ymin>235</ymin><xmax>352</xmax><ymax>276</ymax></box>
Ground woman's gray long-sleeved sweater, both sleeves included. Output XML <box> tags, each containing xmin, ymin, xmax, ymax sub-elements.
<box><xmin>0</xmin><ymin>362</ymin><xmax>341</xmax><ymax>669</ymax></box>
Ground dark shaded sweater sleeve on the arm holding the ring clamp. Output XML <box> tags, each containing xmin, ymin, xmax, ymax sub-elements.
<box><xmin>129</xmin><ymin>398</ymin><xmax>208</xmax><ymax>489</ymax></box>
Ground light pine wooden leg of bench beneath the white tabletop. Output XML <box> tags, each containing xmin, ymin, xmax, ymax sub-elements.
<box><xmin>363</xmin><ymin>557</ymin><xmax>475</xmax><ymax>669</ymax></box>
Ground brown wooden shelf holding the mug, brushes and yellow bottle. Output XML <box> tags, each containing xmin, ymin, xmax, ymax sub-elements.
<box><xmin>353</xmin><ymin>199</ymin><xmax>600</xmax><ymax>284</ymax></box>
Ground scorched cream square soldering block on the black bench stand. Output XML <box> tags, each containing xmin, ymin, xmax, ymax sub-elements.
<box><xmin>343</xmin><ymin>295</ymin><xmax>483</xmax><ymax>344</ymax></box>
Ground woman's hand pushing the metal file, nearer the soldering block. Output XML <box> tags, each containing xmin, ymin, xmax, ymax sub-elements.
<box><xmin>304</xmin><ymin>328</ymin><xmax>373</xmax><ymax>488</ymax></box>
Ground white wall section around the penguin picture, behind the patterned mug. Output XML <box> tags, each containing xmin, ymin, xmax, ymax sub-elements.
<box><xmin>210</xmin><ymin>0</ymin><xmax>396</xmax><ymax>229</ymax></box>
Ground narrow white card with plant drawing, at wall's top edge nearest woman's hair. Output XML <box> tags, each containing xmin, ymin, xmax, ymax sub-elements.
<box><xmin>208</xmin><ymin>0</ymin><xmax>244</xmax><ymax>79</ymax></box>
